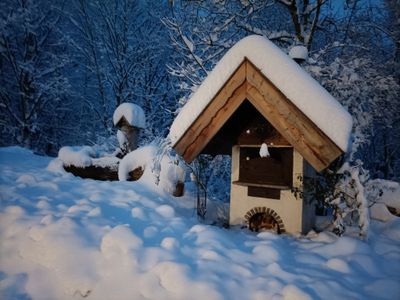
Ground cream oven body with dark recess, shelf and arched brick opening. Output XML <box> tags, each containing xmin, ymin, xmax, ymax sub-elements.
<box><xmin>229</xmin><ymin>145</ymin><xmax>315</xmax><ymax>234</ymax></box>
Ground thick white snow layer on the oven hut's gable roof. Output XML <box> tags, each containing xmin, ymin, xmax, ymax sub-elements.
<box><xmin>169</xmin><ymin>35</ymin><xmax>352</xmax><ymax>151</ymax></box>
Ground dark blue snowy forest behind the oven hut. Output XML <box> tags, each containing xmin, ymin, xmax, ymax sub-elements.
<box><xmin>0</xmin><ymin>0</ymin><xmax>400</xmax><ymax>181</ymax></box>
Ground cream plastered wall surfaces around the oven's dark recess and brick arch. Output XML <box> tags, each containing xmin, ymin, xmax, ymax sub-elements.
<box><xmin>229</xmin><ymin>146</ymin><xmax>311</xmax><ymax>234</ymax></box>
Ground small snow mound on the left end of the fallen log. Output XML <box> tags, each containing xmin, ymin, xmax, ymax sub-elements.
<box><xmin>58</xmin><ymin>146</ymin><xmax>96</xmax><ymax>168</ymax></box>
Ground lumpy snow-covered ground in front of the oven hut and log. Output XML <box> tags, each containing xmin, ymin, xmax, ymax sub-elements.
<box><xmin>0</xmin><ymin>147</ymin><xmax>400</xmax><ymax>300</ymax></box>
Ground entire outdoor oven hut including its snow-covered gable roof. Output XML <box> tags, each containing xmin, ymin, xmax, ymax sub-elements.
<box><xmin>169</xmin><ymin>36</ymin><xmax>352</xmax><ymax>233</ymax></box>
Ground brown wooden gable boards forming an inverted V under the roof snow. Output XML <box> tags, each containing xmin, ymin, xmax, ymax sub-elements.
<box><xmin>174</xmin><ymin>58</ymin><xmax>343</xmax><ymax>171</ymax></box>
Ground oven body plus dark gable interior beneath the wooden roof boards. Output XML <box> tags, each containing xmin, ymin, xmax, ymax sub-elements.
<box><xmin>202</xmin><ymin>100</ymin><xmax>316</xmax><ymax>234</ymax></box>
